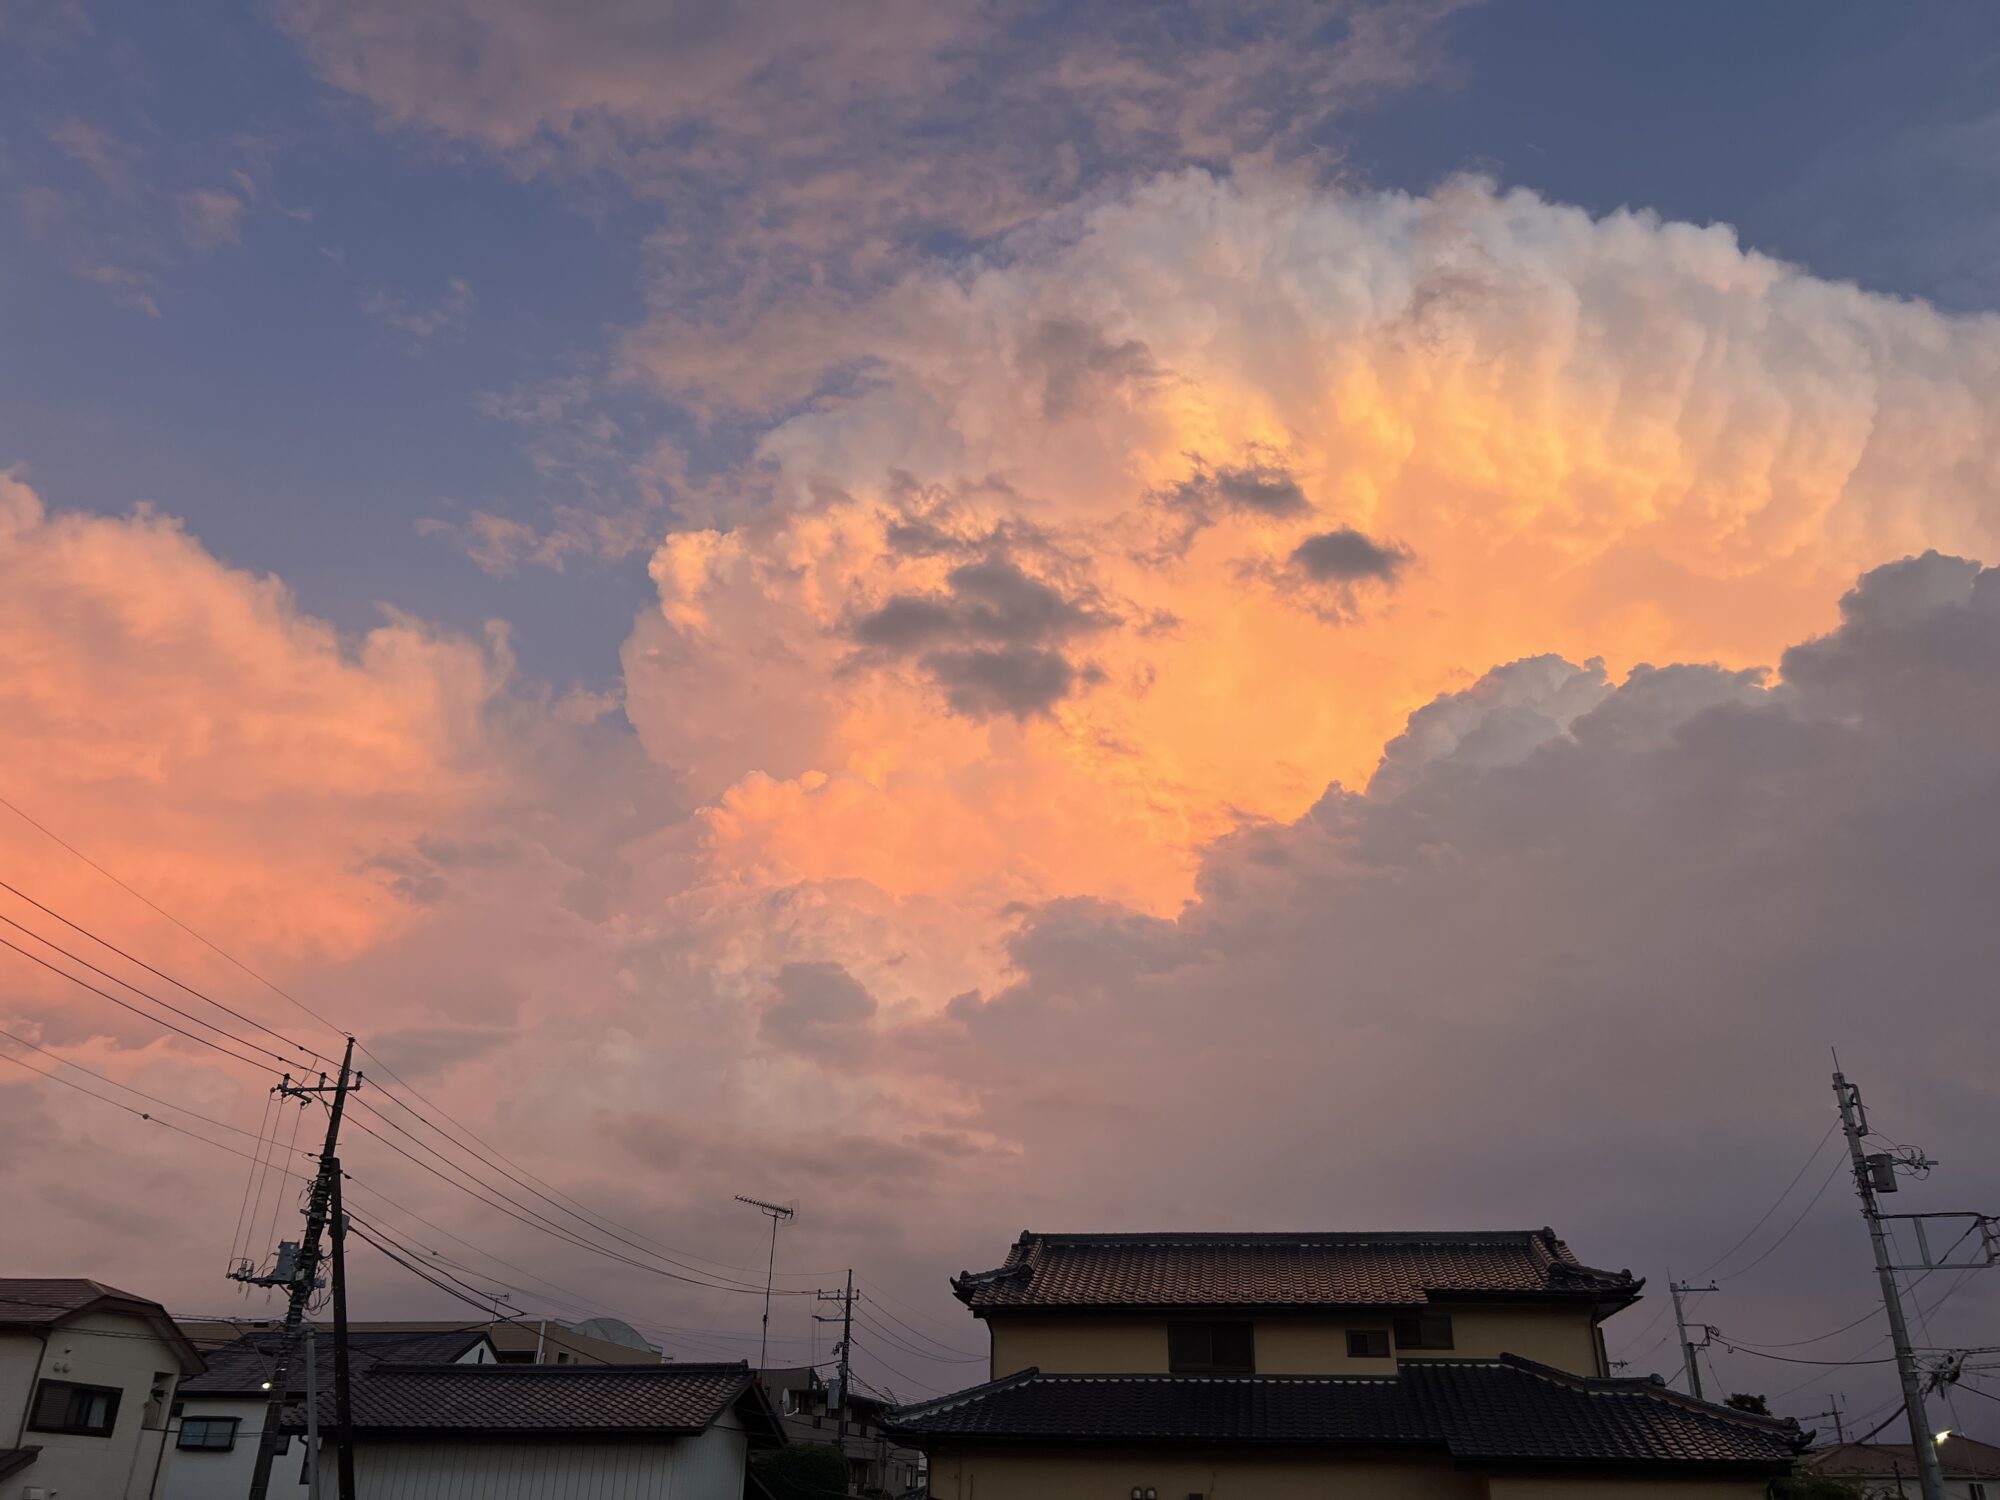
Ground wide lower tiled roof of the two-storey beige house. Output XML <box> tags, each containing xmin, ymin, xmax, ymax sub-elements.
<box><xmin>890</xmin><ymin>1356</ymin><xmax>1806</xmax><ymax>1470</ymax></box>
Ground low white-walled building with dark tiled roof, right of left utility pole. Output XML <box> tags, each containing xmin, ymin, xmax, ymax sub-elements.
<box><xmin>292</xmin><ymin>1360</ymin><xmax>784</xmax><ymax>1500</ymax></box>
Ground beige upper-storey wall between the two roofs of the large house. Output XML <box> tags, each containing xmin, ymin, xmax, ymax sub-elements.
<box><xmin>988</xmin><ymin>1302</ymin><xmax>1604</xmax><ymax>1380</ymax></box>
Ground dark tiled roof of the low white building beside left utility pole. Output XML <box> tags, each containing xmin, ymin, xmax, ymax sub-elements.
<box><xmin>288</xmin><ymin>1360</ymin><xmax>778</xmax><ymax>1438</ymax></box>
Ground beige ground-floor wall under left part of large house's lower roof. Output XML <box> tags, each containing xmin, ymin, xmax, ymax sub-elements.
<box><xmin>930</xmin><ymin>1448</ymin><xmax>1486</xmax><ymax>1500</ymax></box>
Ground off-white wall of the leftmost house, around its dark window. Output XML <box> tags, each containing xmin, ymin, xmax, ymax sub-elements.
<box><xmin>0</xmin><ymin>1312</ymin><xmax>180</xmax><ymax>1500</ymax></box>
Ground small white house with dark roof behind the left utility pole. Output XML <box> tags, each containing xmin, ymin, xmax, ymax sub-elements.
<box><xmin>158</xmin><ymin>1328</ymin><xmax>498</xmax><ymax>1500</ymax></box>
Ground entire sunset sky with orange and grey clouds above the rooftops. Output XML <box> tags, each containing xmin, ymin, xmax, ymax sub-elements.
<box><xmin>0</xmin><ymin>0</ymin><xmax>2000</xmax><ymax>1436</ymax></box>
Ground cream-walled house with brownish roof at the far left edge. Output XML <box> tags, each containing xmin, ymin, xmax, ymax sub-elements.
<box><xmin>0</xmin><ymin>1276</ymin><xmax>202</xmax><ymax>1500</ymax></box>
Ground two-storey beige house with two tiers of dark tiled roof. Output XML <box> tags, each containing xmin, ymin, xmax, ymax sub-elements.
<box><xmin>888</xmin><ymin>1230</ymin><xmax>1806</xmax><ymax>1500</ymax></box>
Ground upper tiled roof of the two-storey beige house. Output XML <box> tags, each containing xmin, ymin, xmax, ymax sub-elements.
<box><xmin>952</xmin><ymin>1230</ymin><xmax>1642</xmax><ymax>1312</ymax></box>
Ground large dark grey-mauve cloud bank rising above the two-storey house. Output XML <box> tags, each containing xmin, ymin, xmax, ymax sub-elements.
<box><xmin>904</xmin><ymin>554</ymin><xmax>2000</xmax><ymax>1426</ymax></box>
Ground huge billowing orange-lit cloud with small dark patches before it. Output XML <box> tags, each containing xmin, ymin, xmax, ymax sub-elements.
<box><xmin>628</xmin><ymin>172</ymin><xmax>2000</xmax><ymax>912</ymax></box>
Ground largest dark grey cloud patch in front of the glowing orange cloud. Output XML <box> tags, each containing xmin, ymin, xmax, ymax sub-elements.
<box><xmin>848</xmin><ymin>552</ymin><xmax>1116</xmax><ymax>718</ymax></box>
